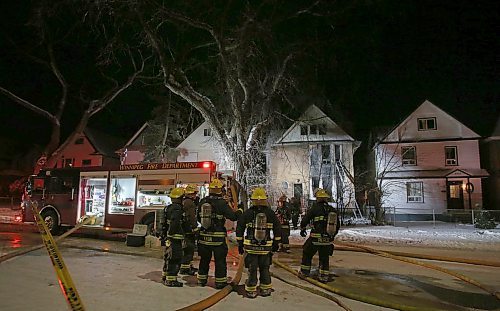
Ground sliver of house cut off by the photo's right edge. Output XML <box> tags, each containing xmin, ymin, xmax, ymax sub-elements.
<box><xmin>482</xmin><ymin>118</ymin><xmax>500</xmax><ymax>210</ymax></box>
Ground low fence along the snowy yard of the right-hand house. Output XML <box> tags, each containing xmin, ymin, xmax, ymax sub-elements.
<box><xmin>366</xmin><ymin>206</ymin><xmax>500</xmax><ymax>226</ymax></box>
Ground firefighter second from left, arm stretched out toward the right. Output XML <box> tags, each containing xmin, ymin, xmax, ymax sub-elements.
<box><xmin>198</xmin><ymin>179</ymin><xmax>243</xmax><ymax>289</ymax></box>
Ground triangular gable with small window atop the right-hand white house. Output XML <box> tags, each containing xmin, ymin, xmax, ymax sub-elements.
<box><xmin>379</xmin><ymin>100</ymin><xmax>480</xmax><ymax>142</ymax></box>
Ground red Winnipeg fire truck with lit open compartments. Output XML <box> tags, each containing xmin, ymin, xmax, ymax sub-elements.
<box><xmin>23</xmin><ymin>161</ymin><xmax>216</xmax><ymax>234</ymax></box>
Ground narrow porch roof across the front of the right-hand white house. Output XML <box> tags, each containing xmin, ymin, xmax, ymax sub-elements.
<box><xmin>379</xmin><ymin>168</ymin><xmax>490</xmax><ymax>179</ymax></box>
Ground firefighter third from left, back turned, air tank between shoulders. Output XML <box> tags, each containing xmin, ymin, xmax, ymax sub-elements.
<box><xmin>236</xmin><ymin>188</ymin><xmax>281</xmax><ymax>298</ymax></box>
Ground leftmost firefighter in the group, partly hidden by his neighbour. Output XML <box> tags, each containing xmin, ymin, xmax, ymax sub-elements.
<box><xmin>179</xmin><ymin>184</ymin><xmax>198</xmax><ymax>275</ymax></box>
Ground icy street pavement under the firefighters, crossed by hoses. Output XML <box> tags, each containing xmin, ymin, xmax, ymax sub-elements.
<box><xmin>0</xmin><ymin>228</ymin><xmax>500</xmax><ymax>310</ymax></box>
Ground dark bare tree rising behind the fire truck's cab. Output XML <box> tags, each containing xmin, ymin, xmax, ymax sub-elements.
<box><xmin>0</xmin><ymin>1</ymin><xmax>145</xmax><ymax>173</ymax></box>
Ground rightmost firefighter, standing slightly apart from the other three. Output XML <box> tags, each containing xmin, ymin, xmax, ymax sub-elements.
<box><xmin>299</xmin><ymin>188</ymin><xmax>340</xmax><ymax>283</ymax></box>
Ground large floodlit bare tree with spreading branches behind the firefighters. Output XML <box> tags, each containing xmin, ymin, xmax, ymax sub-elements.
<box><xmin>85</xmin><ymin>0</ymin><xmax>336</xmax><ymax>191</ymax></box>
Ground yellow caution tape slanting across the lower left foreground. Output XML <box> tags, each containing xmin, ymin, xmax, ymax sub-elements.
<box><xmin>31</xmin><ymin>201</ymin><xmax>85</xmax><ymax>311</ymax></box>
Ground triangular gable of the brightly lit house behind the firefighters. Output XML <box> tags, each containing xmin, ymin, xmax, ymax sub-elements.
<box><xmin>275</xmin><ymin>105</ymin><xmax>354</xmax><ymax>145</ymax></box>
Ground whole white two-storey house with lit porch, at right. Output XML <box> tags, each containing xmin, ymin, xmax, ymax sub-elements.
<box><xmin>373</xmin><ymin>100</ymin><xmax>488</xmax><ymax>220</ymax></box>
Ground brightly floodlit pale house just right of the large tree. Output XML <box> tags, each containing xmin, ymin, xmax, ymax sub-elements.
<box><xmin>268</xmin><ymin>105</ymin><xmax>360</xmax><ymax>212</ymax></box>
